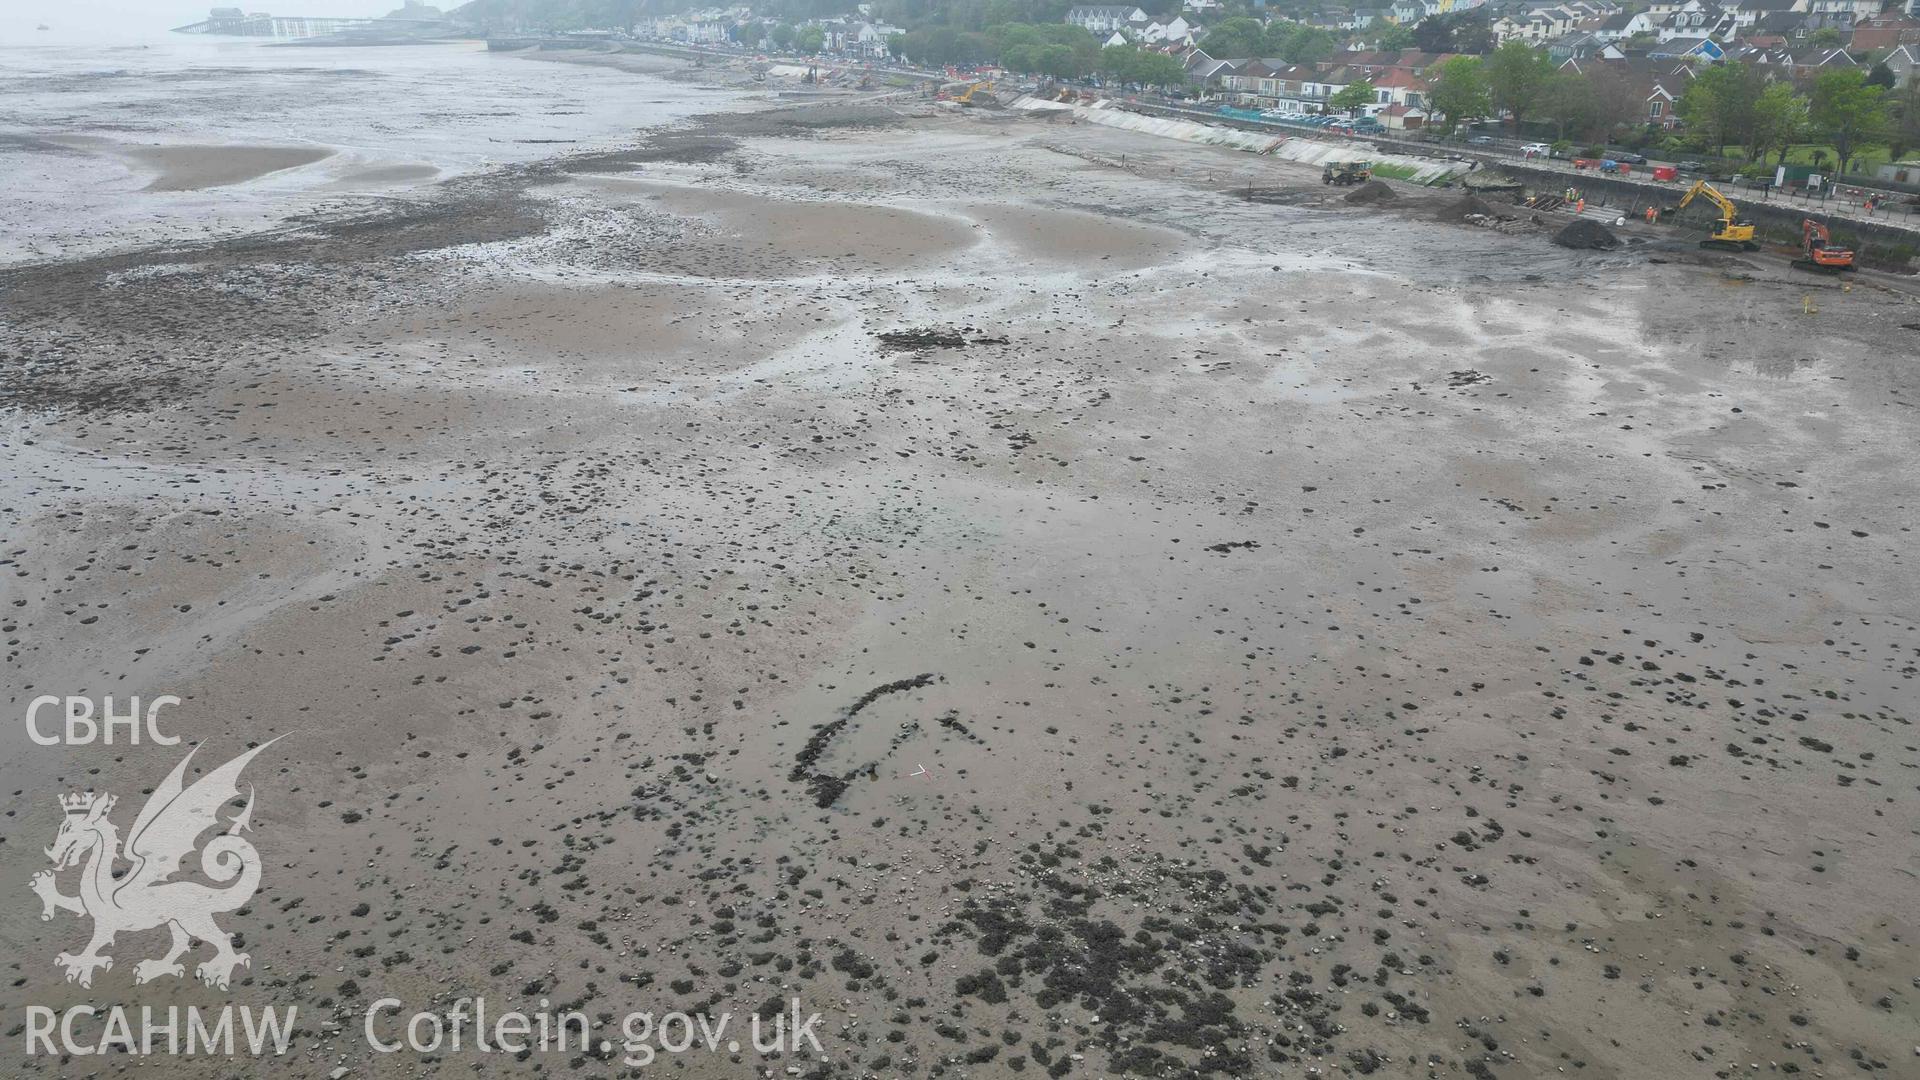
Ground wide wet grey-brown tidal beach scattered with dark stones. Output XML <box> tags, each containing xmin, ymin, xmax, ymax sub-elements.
<box><xmin>0</xmin><ymin>50</ymin><xmax>1920</xmax><ymax>1080</ymax></box>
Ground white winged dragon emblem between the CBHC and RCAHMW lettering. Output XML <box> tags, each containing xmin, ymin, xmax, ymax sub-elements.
<box><xmin>33</xmin><ymin>738</ymin><xmax>278</xmax><ymax>990</ymax></box>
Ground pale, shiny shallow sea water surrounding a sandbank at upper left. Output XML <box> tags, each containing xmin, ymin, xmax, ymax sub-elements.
<box><xmin>0</xmin><ymin>35</ymin><xmax>728</xmax><ymax>263</ymax></box>
